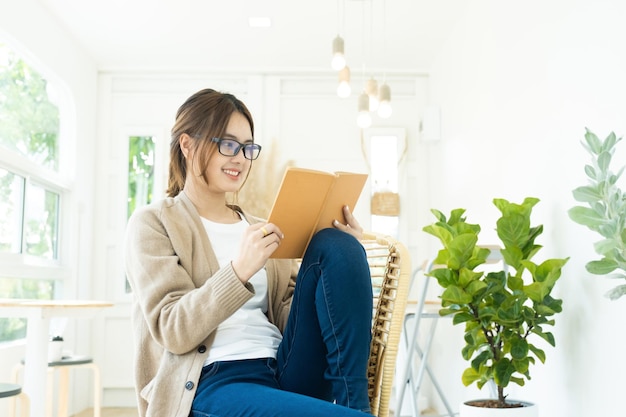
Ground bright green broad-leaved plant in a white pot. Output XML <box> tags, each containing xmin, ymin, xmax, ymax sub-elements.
<box><xmin>423</xmin><ymin>198</ymin><xmax>568</xmax><ymax>416</ymax></box>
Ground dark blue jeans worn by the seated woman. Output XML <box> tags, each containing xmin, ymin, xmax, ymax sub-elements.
<box><xmin>190</xmin><ymin>229</ymin><xmax>372</xmax><ymax>417</ymax></box>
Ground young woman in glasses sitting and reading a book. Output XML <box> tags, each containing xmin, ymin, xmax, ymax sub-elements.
<box><xmin>125</xmin><ymin>89</ymin><xmax>372</xmax><ymax>417</ymax></box>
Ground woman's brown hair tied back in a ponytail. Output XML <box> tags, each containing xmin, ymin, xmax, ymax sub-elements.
<box><xmin>166</xmin><ymin>88</ymin><xmax>254</xmax><ymax>197</ymax></box>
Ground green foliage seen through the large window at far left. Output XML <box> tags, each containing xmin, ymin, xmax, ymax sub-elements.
<box><xmin>0</xmin><ymin>42</ymin><xmax>60</xmax><ymax>341</ymax></box>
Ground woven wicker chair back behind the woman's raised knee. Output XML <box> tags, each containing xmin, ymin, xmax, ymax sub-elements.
<box><xmin>362</xmin><ymin>233</ymin><xmax>411</xmax><ymax>417</ymax></box>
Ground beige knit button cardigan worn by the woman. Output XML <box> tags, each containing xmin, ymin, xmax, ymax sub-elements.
<box><xmin>124</xmin><ymin>192</ymin><xmax>297</xmax><ymax>417</ymax></box>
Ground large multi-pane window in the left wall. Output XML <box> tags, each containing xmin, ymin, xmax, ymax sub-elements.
<box><xmin>0</xmin><ymin>41</ymin><xmax>69</xmax><ymax>342</ymax></box>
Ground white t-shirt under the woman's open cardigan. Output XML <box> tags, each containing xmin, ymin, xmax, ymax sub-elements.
<box><xmin>202</xmin><ymin>214</ymin><xmax>282</xmax><ymax>366</ymax></box>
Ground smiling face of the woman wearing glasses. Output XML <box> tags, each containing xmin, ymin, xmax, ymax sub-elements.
<box><xmin>196</xmin><ymin>112</ymin><xmax>253</xmax><ymax>193</ymax></box>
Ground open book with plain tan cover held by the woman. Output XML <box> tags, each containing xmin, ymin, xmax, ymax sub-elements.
<box><xmin>268</xmin><ymin>167</ymin><xmax>367</xmax><ymax>259</ymax></box>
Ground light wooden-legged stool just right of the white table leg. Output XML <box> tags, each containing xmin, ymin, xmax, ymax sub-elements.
<box><xmin>12</xmin><ymin>356</ymin><xmax>102</xmax><ymax>417</ymax></box>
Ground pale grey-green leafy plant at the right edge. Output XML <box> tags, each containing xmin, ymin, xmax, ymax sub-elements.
<box><xmin>568</xmin><ymin>129</ymin><xmax>626</xmax><ymax>300</ymax></box>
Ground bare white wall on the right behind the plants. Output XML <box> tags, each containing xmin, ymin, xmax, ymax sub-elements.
<box><xmin>420</xmin><ymin>0</ymin><xmax>626</xmax><ymax>417</ymax></box>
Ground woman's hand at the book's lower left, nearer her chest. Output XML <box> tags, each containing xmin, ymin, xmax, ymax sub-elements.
<box><xmin>232</xmin><ymin>223</ymin><xmax>284</xmax><ymax>284</ymax></box>
